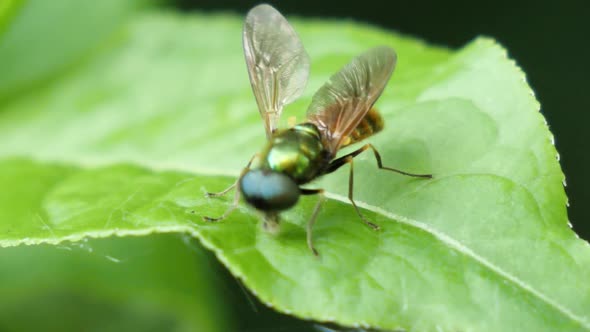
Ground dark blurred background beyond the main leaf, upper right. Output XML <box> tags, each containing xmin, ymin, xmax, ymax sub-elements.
<box><xmin>178</xmin><ymin>0</ymin><xmax>590</xmax><ymax>239</ymax></box>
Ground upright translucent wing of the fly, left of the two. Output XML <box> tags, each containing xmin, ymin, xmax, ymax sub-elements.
<box><xmin>243</xmin><ymin>5</ymin><xmax>309</xmax><ymax>139</ymax></box>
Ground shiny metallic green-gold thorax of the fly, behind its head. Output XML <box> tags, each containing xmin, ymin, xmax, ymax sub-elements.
<box><xmin>260</xmin><ymin>123</ymin><xmax>330</xmax><ymax>184</ymax></box>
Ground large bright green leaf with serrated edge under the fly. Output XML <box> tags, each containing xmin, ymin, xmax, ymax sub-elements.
<box><xmin>0</xmin><ymin>7</ymin><xmax>590</xmax><ymax>331</ymax></box>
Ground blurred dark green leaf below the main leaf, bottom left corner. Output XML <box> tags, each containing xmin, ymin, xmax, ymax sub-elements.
<box><xmin>0</xmin><ymin>235</ymin><xmax>233</xmax><ymax>332</ymax></box>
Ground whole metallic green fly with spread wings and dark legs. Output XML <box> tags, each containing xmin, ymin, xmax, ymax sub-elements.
<box><xmin>204</xmin><ymin>5</ymin><xmax>432</xmax><ymax>255</ymax></box>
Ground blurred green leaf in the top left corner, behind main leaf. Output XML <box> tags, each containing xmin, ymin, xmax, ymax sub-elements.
<box><xmin>0</xmin><ymin>0</ymin><xmax>147</xmax><ymax>100</ymax></box>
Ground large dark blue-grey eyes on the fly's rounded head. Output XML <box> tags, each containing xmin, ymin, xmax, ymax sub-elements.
<box><xmin>240</xmin><ymin>170</ymin><xmax>301</xmax><ymax>212</ymax></box>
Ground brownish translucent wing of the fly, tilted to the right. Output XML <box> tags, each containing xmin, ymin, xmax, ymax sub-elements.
<box><xmin>307</xmin><ymin>46</ymin><xmax>396</xmax><ymax>155</ymax></box>
